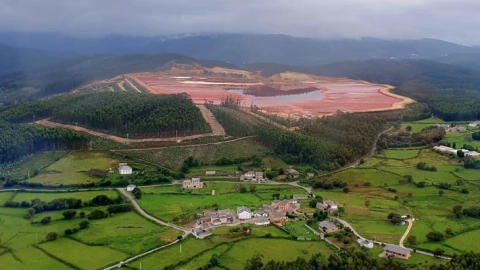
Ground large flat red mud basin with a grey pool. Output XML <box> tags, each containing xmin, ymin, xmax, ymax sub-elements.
<box><xmin>135</xmin><ymin>74</ymin><xmax>412</xmax><ymax>115</ymax></box>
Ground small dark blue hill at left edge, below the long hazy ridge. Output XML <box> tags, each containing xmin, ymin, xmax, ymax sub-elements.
<box><xmin>0</xmin><ymin>44</ymin><xmax>62</xmax><ymax>76</ymax></box>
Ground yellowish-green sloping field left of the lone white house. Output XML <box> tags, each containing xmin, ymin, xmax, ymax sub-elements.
<box><xmin>28</xmin><ymin>151</ymin><xmax>118</xmax><ymax>186</ymax></box>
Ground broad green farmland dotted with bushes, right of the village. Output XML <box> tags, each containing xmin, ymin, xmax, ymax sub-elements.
<box><xmin>315</xmin><ymin>149</ymin><xmax>480</xmax><ymax>255</ymax></box>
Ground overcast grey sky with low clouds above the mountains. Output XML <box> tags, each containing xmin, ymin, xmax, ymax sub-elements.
<box><xmin>0</xmin><ymin>0</ymin><xmax>480</xmax><ymax>45</ymax></box>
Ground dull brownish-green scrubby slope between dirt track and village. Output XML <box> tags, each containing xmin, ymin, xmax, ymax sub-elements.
<box><xmin>122</xmin><ymin>138</ymin><xmax>268</xmax><ymax>168</ymax></box>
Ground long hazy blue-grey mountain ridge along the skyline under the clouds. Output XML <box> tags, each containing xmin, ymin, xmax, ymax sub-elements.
<box><xmin>0</xmin><ymin>33</ymin><xmax>480</xmax><ymax>66</ymax></box>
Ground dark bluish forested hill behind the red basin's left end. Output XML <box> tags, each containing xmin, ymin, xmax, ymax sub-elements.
<box><xmin>0</xmin><ymin>54</ymin><xmax>233</xmax><ymax>105</ymax></box>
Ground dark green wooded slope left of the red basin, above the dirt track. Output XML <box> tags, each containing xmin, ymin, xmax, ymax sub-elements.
<box><xmin>0</xmin><ymin>92</ymin><xmax>210</xmax><ymax>138</ymax></box>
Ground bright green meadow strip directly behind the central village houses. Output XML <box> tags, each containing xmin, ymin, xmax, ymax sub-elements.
<box><xmin>139</xmin><ymin>182</ymin><xmax>305</xmax><ymax>224</ymax></box>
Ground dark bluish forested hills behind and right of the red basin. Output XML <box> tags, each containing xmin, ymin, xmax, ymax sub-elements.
<box><xmin>247</xmin><ymin>60</ymin><xmax>480</xmax><ymax>121</ymax></box>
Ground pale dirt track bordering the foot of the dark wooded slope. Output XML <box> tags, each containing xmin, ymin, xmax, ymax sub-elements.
<box><xmin>35</xmin><ymin>104</ymin><xmax>227</xmax><ymax>143</ymax></box>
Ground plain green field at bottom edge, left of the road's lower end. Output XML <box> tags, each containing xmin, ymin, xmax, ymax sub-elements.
<box><xmin>40</xmin><ymin>238</ymin><xmax>128</xmax><ymax>270</ymax></box>
